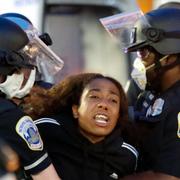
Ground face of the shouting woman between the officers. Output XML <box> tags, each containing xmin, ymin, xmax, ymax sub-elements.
<box><xmin>73</xmin><ymin>79</ymin><xmax>120</xmax><ymax>143</ymax></box>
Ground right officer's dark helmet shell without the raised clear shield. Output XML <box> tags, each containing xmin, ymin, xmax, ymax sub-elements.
<box><xmin>126</xmin><ymin>8</ymin><xmax>180</xmax><ymax>55</ymax></box>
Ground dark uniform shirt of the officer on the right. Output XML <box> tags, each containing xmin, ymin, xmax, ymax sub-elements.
<box><xmin>138</xmin><ymin>81</ymin><xmax>180</xmax><ymax>178</ymax></box>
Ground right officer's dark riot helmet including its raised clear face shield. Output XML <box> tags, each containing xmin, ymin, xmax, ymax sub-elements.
<box><xmin>101</xmin><ymin>8</ymin><xmax>180</xmax><ymax>55</ymax></box>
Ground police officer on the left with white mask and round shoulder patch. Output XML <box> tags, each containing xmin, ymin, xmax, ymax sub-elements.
<box><xmin>0</xmin><ymin>17</ymin><xmax>59</xmax><ymax>180</ymax></box>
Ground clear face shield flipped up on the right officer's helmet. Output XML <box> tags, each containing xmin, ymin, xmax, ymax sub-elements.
<box><xmin>100</xmin><ymin>10</ymin><xmax>150</xmax><ymax>52</ymax></box>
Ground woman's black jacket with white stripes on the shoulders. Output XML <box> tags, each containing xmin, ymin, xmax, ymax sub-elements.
<box><xmin>34</xmin><ymin>113</ymin><xmax>138</xmax><ymax>180</ymax></box>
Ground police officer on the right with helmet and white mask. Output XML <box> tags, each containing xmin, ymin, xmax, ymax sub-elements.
<box><xmin>119</xmin><ymin>8</ymin><xmax>180</xmax><ymax>180</ymax></box>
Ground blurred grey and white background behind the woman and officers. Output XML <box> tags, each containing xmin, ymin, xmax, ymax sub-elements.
<box><xmin>0</xmin><ymin>0</ymin><xmax>180</xmax><ymax>87</ymax></box>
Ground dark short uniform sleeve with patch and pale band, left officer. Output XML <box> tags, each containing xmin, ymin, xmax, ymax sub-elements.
<box><xmin>0</xmin><ymin>97</ymin><xmax>51</xmax><ymax>174</ymax></box>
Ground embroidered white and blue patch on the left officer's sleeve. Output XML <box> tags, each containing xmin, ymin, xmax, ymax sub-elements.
<box><xmin>16</xmin><ymin>116</ymin><xmax>43</xmax><ymax>151</ymax></box>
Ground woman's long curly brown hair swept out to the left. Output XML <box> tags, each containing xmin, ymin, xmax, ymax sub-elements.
<box><xmin>24</xmin><ymin>73</ymin><xmax>128</xmax><ymax>125</ymax></box>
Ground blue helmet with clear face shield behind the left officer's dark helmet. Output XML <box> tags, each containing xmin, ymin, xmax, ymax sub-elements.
<box><xmin>1</xmin><ymin>13</ymin><xmax>64</xmax><ymax>82</ymax></box>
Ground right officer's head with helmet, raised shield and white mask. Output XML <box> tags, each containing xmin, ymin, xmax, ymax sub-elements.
<box><xmin>102</xmin><ymin>8</ymin><xmax>180</xmax><ymax>91</ymax></box>
